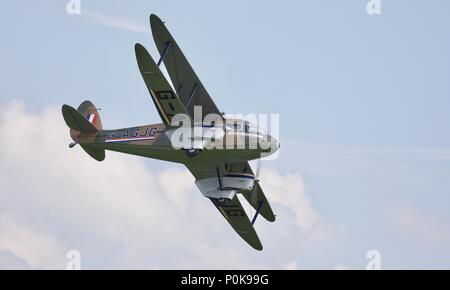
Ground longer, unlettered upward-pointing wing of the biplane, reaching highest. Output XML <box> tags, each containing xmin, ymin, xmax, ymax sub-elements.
<box><xmin>150</xmin><ymin>14</ymin><xmax>220</xmax><ymax>120</ymax></box>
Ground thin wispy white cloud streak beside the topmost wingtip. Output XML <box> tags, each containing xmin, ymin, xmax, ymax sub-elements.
<box><xmin>81</xmin><ymin>10</ymin><xmax>150</xmax><ymax>34</ymax></box>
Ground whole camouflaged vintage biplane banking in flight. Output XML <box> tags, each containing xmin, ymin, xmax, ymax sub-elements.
<box><xmin>62</xmin><ymin>15</ymin><xmax>279</xmax><ymax>250</ymax></box>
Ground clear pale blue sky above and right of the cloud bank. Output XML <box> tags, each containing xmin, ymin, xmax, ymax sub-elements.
<box><xmin>0</xmin><ymin>0</ymin><xmax>450</xmax><ymax>268</ymax></box>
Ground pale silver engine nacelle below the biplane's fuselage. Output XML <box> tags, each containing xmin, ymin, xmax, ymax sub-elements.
<box><xmin>195</xmin><ymin>173</ymin><xmax>255</xmax><ymax>199</ymax></box>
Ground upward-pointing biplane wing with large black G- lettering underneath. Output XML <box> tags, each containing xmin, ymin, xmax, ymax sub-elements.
<box><xmin>135</xmin><ymin>44</ymin><xmax>189</xmax><ymax>127</ymax></box>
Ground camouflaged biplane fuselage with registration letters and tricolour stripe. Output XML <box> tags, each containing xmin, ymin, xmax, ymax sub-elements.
<box><xmin>71</xmin><ymin>123</ymin><xmax>279</xmax><ymax>164</ymax></box>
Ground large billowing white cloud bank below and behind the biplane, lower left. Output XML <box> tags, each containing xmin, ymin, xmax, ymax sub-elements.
<box><xmin>0</xmin><ymin>102</ymin><xmax>333</xmax><ymax>269</ymax></box>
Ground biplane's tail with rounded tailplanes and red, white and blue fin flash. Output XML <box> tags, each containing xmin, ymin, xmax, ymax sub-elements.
<box><xmin>62</xmin><ymin>101</ymin><xmax>105</xmax><ymax>161</ymax></box>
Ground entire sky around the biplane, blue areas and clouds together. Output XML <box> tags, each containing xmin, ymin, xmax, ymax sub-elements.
<box><xmin>0</xmin><ymin>0</ymin><xmax>450</xmax><ymax>269</ymax></box>
